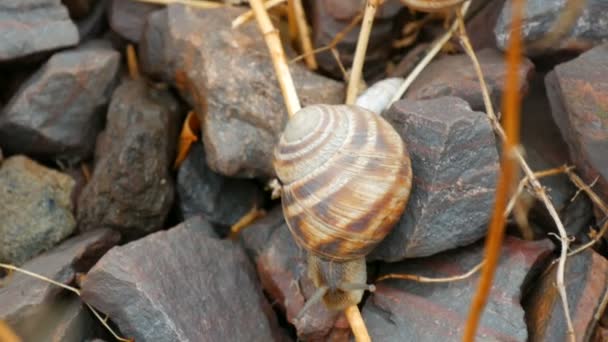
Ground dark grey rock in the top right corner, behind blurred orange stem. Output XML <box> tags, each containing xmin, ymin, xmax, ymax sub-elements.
<box><xmin>494</xmin><ymin>0</ymin><xmax>608</xmax><ymax>55</ymax></box>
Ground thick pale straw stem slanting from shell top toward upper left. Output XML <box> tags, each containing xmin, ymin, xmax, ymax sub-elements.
<box><xmin>249</xmin><ymin>0</ymin><xmax>302</xmax><ymax>116</ymax></box>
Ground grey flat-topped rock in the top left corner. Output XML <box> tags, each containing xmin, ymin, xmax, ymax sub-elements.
<box><xmin>0</xmin><ymin>0</ymin><xmax>78</xmax><ymax>62</ymax></box>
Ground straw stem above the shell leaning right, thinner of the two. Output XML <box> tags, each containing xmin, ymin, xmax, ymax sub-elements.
<box><xmin>346</xmin><ymin>0</ymin><xmax>383</xmax><ymax>104</ymax></box>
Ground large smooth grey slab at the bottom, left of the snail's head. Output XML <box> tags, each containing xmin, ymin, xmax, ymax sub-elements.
<box><xmin>82</xmin><ymin>221</ymin><xmax>276</xmax><ymax>342</ymax></box>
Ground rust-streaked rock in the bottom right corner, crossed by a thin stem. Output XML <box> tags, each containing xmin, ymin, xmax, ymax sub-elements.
<box><xmin>524</xmin><ymin>249</ymin><xmax>608</xmax><ymax>341</ymax></box>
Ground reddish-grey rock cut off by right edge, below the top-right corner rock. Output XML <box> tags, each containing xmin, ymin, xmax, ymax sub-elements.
<box><xmin>545</xmin><ymin>44</ymin><xmax>608</xmax><ymax>214</ymax></box>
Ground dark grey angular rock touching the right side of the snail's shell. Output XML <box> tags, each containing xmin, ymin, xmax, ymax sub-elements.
<box><xmin>370</xmin><ymin>97</ymin><xmax>498</xmax><ymax>261</ymax></box>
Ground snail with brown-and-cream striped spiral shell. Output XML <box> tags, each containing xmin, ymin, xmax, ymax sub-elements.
<box><xmin>273</xmin><ymin>105</ymin><xmax>412</xmax><ymax>317</ymax></box>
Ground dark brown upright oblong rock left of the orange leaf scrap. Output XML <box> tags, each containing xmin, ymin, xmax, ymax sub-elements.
<box><xmin>77</xmin><ymin>80</ymin><xmax>179</xmax><ymax>236</ymax></box>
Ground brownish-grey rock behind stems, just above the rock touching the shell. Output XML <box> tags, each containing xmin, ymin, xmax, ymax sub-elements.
<box><xmin>405</xmin><ymin>49</ymin><xmax>534</xmax><ymax>112</ymax></box>
